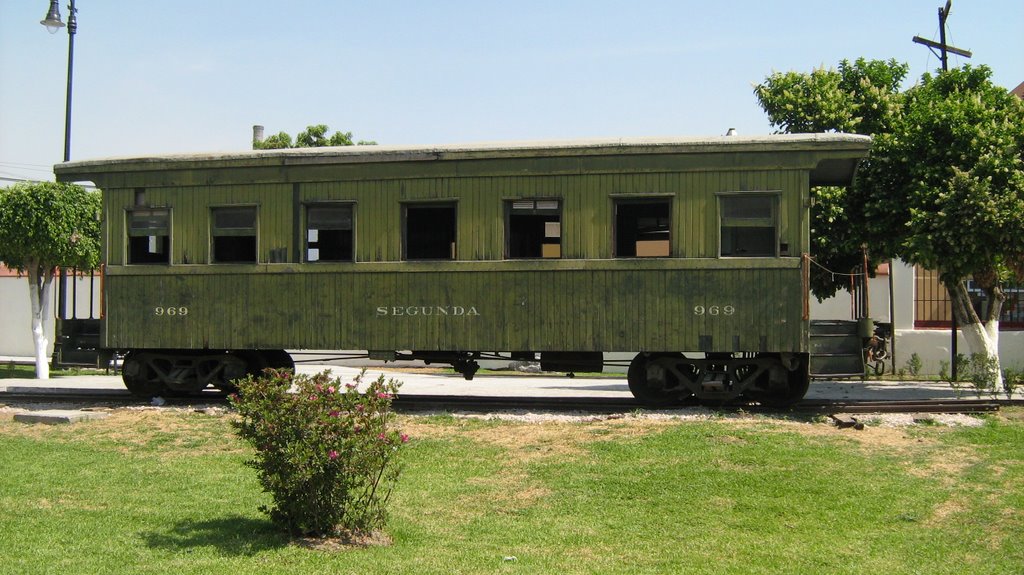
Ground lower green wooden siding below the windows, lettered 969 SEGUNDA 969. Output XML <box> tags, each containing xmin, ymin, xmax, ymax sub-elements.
<box><xmin>105</xmin><ymin>260</ymin><xmax>806</xmax><ymax>352</ymax></box>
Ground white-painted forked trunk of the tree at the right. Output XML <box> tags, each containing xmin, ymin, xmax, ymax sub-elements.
<box><xmin>946</xmin><ymin>280</ymin><xmax>1006</xmax><ymax>392</ymax></box>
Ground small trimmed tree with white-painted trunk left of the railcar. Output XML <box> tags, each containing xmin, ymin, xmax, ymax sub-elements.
<box><xmin>0</xmin><ymin>182</ymin><xmax>100</xmax><ymax>380</ymax></box>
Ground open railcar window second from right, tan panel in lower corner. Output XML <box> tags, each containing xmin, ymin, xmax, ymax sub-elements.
<box><xmin>615</xmin><ymin>200</ymin><xmax>672</xmax><ymax>258</ymax></box>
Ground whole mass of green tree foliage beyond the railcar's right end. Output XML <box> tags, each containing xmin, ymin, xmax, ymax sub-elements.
<box><xmin>755</xmin><ymin>58</ymin><xmax>1024</xmax><ymax>304</ymax></box>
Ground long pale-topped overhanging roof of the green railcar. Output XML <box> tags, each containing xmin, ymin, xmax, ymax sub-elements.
<box><xmin>53</xmin><ymin>133</ymin><xmax>871</xmax><ymax>173</ymax></box>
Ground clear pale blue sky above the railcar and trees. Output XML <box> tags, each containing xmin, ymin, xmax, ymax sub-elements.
<box><xmin>0</xmin><ymin>0</ymin><xmax>1024</xmax><ymax>183</ymax></box>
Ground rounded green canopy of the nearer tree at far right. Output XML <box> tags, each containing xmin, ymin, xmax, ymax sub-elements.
<box><xmin>850</xmin><ymin>65</ymin><xmax>1024</xmax><ymax>290</ymax></box>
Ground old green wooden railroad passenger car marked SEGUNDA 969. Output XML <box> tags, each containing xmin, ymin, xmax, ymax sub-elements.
<box><xmin>55</xmin><ymin>134</ymin><xmax>870</xmax><ymax>404</ymax></box>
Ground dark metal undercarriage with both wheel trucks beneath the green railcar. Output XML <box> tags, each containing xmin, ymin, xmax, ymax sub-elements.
<box><xmin>122</xmin><ymin>343</ymin><xmax>810</xmax><ymax>407</ymax></box>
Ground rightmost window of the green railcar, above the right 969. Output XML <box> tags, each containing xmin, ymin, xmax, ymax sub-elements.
<box><xmin>719</xmin><ymin>193</ymin><xmax>778</xmax><ymax>258</ymax></box>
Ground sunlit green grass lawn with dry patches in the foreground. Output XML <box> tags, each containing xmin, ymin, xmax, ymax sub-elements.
<box><xmin>0</xmin><ymin>409</ymin><xmax>1024</xmax><ymax>575</ymax></box>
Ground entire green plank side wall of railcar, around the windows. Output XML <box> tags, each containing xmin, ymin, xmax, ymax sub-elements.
<box><xmin>104</xmin><ymin>161</ymin><xmax>808</xmax><ymax>351</ymax></box>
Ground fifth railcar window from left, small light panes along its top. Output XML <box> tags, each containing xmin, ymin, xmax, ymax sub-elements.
<box><xmin>505</xmin><ymin>200</ymin><xmax>562</xmax><ymax>259</ymax></box>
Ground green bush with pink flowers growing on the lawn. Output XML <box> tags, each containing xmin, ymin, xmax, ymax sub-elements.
<box><xmin>230</xmin><ymin>369</ymin><xmax>409</xmax><ymax>536</ymax></box>
